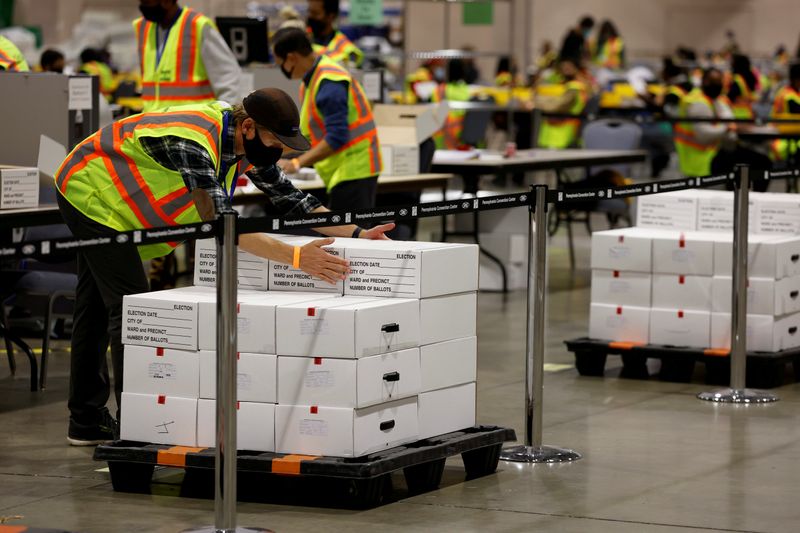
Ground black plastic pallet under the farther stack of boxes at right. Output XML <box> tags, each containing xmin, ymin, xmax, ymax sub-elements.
<box><xmin>565</xmin><ymin>337</ymin><xmax>800</xmax><ymax>389</ymax></box>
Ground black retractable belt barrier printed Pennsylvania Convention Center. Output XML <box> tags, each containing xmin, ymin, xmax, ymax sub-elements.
<box><xmin>0</xmin><ymin>169</ymin><xmax>800</xmax><ymax>259</ymax></box>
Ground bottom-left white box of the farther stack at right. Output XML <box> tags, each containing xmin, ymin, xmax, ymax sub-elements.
<box><xmin>589</xmin><ymin>303</ymin><xmax>650</xmax><ymax>344</ymax></box>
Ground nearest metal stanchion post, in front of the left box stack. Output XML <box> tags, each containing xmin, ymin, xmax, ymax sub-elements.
<box><xmin>185</xmin><ymin>213</ymin><xmax>272</xmax><ymax>533</ymax></box>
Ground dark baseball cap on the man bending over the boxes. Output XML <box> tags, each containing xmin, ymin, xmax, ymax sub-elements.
<box><xmin>242</xmin><ymin>87</ymin><xmax>311</xmax><ymax>151</ymax></box>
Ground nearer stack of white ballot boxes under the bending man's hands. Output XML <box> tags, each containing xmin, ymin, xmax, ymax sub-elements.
<box><xmin>121</xmin><ymin>236</ymin><xmax>478</xmax><ymax>457</ymax></box>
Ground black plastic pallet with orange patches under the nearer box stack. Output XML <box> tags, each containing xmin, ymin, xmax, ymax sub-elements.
<box><xmin>94</xmin><ymin>426</ymin><xmax>516</xmax><ymax>508</ymax></box>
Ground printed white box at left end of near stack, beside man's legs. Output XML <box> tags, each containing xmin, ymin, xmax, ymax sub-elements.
<box><xmin>122</xmin><ymin>287</ymin><xmax>216</xmax><ymax>351</ymax></box>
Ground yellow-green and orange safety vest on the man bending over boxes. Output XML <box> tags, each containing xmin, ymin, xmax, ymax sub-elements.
<box><xmin>55</xmin><ymin>102</ymin><xmax>241</xmax><ymax>259</ymax></box>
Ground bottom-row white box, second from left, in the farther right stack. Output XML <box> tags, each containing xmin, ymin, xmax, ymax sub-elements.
<box><xmin>650</xmin><ymin>308</ymin><xmax>711</xmax><ymax>348</ymax></box>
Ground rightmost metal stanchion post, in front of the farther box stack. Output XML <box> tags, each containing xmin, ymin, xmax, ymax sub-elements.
<box><xmin>697</xmin><ymin>165</ymin><xmax>778</xmax><ymax>404</ymax></box>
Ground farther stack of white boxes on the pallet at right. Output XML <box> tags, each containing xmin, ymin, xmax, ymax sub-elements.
<box><xmin>589</xmin><ymin>190</ymin><xmax>800</xmax><ymax>351</ymax></box>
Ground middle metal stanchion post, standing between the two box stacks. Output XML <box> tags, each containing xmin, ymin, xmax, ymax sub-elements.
<box><xmin>500</xmin><ymin>185</ymin><xmax>581</xmax><ymax>463</ymax></box>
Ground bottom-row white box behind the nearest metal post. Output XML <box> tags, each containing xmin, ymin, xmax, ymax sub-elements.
<box><xmin>197</xmin><ymin>399</ymin><xmax>275</xmax><ymax>452</ymax></box>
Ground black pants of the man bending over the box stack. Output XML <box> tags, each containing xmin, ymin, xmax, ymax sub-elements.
<box><xmin>58</xmin><ymin>194</ymin><xmax>149</xmax><ymax>429</ymax></box>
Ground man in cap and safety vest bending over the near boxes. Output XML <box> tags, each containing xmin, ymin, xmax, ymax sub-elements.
<box><xmin>55</xmin><ymin>89</ymin><xmax>394</xmax><ymax>446</ymax></box>
